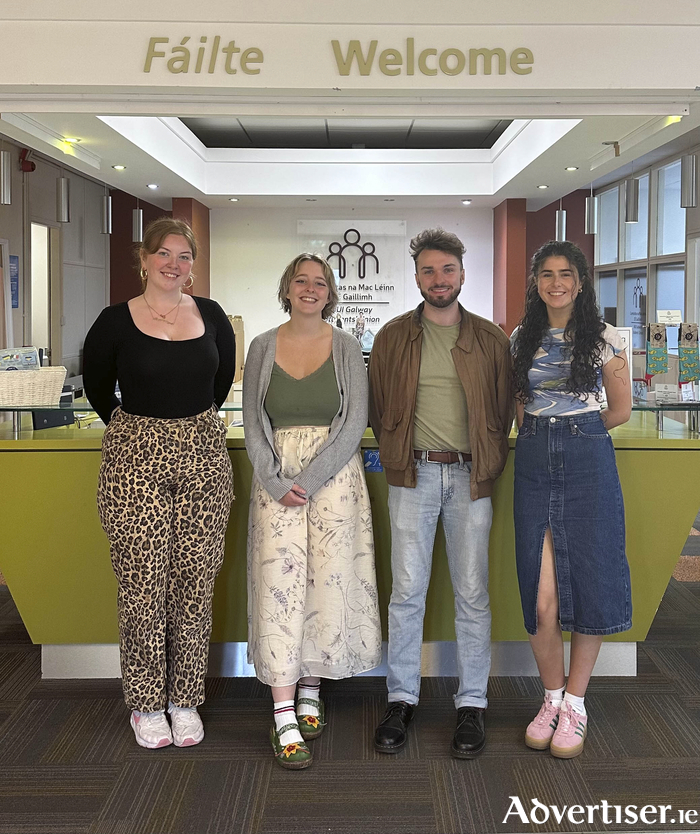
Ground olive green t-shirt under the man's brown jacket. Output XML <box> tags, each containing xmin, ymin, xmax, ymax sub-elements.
<box><xmin>413</xmin><ymin>316</ymin><xmax>471</xmax><ymax>452</ymax></box>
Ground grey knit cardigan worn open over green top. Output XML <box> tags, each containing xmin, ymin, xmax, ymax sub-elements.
<box><xmin>243</xmin><ymin>327</ymin><xmax>368</xmax><ymax>501</ymax></box>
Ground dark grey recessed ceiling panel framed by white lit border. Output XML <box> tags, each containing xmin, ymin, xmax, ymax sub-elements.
<box><xmin>182</xmin><ymin>117</ymin><xmax>510</xmax><ymax>149</ymax></box>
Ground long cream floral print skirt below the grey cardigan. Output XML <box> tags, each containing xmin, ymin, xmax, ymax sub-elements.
<box><xmin>248</xmin><ymin>426</ymin><xmax>382</xmax><ymax>686</ymax></box>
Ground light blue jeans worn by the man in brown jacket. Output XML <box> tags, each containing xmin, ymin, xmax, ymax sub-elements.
<box><xmin>387</xmin><ymin>462</ymin><xmax>492</xmax><ymax>709</ymax></box>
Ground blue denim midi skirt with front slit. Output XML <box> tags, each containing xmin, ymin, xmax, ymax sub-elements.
<box><xmin>514</xmin><ymin>412</ymin><xmax>632</xmax><ymax>634</ymax></box>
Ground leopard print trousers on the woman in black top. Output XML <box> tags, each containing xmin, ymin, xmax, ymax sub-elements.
<box><xmin>97</xmin><ymin>406</ymin><xmax>233</xmax><ymax>712</ymax></box>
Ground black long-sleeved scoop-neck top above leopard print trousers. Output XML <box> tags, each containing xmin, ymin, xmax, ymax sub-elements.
<box><xmin>83</xmin><ymin>297</ymin><xmax>236</xmax><ymax>425</ymax></box>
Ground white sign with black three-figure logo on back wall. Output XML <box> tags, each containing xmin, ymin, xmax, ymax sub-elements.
<box><xmin>297</xmin><ymin>219</ymin><xmax>412</xmax><ymax>348</ymax></box>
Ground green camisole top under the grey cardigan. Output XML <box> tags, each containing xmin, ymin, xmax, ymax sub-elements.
<box><xmin>265</xmin><ymin>354</ymin><xmax>340</xmax><ymax>429</ymax></box>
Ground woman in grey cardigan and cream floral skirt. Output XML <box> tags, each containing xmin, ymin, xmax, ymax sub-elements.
<box><xmin>243</xmin><ymin>253</ymin><xmax>381</xmax><ymax>769</ymax></box>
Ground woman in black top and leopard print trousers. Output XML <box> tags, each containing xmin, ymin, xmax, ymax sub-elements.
<box><xmin>83</xmin><ymin>218</ymin><xmax>235</xmax><ymax>748</ymax></box>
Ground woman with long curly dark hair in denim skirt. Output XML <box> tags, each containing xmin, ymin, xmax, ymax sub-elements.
<box><xmin>511</xmin><ymin>241</ymin><xmax>632</xmax><ymax>758</ymax></box>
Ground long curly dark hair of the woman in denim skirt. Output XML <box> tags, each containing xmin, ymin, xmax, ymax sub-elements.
<box><xmin>513</xmin><ymin>240</ymin><xmax>605</xmax><ymax>403</ymax></box>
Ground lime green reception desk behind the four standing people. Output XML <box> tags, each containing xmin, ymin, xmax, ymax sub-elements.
<box><xmin>0</xmin><ymin>413</ymin><xmax>700</xmax><ymax>676</ymax></box>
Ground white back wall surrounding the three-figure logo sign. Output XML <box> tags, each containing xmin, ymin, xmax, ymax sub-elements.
<box><xmin>211</xmin><ymin>207</ymin><xmax>493</xmax><ymax>352</ymax></box>
